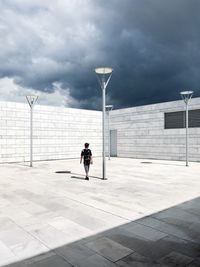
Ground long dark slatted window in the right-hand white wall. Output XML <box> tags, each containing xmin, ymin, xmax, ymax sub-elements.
<box><xmin>164</xmin><ymin>109</ymin><xmax>200</xmax><ymax>129</ymax></box>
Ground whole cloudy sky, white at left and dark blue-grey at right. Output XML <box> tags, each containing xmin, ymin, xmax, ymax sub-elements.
<box><xmin>0</xmin><ymin>0</ymin><xmax>200</xmax><ymax>109</ymax></box>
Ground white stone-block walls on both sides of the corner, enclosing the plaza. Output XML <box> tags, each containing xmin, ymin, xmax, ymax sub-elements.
<box><xmin>0</xmin><ymin>98</ymin><xmax>200</xmax><ymax>163</ymax></box>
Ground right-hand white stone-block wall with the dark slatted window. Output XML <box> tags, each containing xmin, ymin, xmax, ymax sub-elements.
<box><xmin>110</xmin><ymin>98</ymin><xmax>200</xmax><ymax>161</ymax></box>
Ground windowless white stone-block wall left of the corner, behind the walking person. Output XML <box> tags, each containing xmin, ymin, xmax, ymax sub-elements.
<box><xmin>0</xmin><ymin>102</ymin><xmax>102</xmax><ymax>163</ymax></box>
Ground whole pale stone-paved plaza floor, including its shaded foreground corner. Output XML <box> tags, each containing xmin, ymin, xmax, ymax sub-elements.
<box><xmin>0</xmin><ymin>158</ymin><xmax>200</xmax><ymax>267</ymax></box>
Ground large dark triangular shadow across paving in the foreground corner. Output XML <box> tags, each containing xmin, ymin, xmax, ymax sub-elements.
<box><xmin>2</xmin><ymin>197</ymin><xmax>200</xmax><ymax>267</ymax></box>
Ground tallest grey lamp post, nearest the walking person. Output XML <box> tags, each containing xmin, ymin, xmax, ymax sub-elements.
<box><xmin>95</xmin><ymin>67</ymin><xmax>113</xmax><ymax>180</ymax></box>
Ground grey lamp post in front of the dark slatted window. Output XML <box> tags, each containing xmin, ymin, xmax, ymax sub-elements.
<box><xmin>180</xmin><ymin>91</ymin><xmax>193</xmax><ymax>166</ymax></box>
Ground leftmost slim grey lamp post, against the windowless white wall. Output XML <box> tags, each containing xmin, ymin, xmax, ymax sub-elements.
<box><xmin>26</xmin><ymin>95</ymin><xmax>38</xmax><ymax>167</ymax></box>
